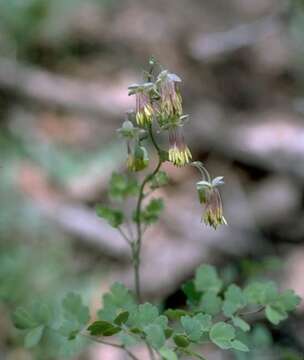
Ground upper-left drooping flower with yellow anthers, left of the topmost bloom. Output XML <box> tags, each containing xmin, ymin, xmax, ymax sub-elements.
<box><xmin>129</xmin><ymin>83</ymin><xmax>154</xmax><ymax>127</ymax></box>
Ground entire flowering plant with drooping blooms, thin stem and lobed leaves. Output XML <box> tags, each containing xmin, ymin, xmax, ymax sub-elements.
<box><xmin>13</xmin><ymin>59</ymin><xmax>300</xmax><ymax>360</ymax></box>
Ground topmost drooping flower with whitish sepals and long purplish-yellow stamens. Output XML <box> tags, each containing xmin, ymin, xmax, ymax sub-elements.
<box><xmin>156</xmin><ymin>70</ymin><xmax>183</xmax><ymax>121</ymax></box>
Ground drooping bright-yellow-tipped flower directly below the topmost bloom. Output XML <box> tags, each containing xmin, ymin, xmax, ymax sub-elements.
<box><xmin>168</xmin><ymin>126</ymin><xmax>192</xmax><ymax>166</ymax></box>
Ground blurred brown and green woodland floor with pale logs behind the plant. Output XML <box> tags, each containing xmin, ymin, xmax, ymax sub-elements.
<box><xmin>0</xmin><ymin>0</ymin><xmax>304</xmax><ymax>360</ymax></box>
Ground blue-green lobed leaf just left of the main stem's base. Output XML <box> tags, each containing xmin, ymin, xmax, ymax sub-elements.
<box><xmin>98</xmin><ymin>283</ymin><xmax>136</xmax><ymax>322</ymax></box>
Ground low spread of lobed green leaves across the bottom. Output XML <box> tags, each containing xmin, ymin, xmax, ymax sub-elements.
<box><xmin>13</xmin><ymin>265</ymin><xmax>300</xmax><ymax>360</ymax></box>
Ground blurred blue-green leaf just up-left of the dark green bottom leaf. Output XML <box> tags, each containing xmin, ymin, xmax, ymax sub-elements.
<box><xmin>62</xmin><ymin>293</ymin><xmax>90</xmax><ymax>326</ymax></box>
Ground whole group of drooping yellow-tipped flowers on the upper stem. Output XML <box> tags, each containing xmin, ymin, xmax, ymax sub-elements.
<box><xmin>123</xmin><ymin>64</ymin><xmax>227</xmax><ymax>229</ymax></box>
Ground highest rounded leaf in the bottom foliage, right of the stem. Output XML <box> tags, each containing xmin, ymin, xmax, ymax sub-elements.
<box><xmin>194</xmin><ymin>265</ymin><xmax>222</xmax><ymax>294</ymax></box>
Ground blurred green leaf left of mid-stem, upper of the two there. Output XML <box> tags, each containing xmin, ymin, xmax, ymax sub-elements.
<box><xmin>109</xmin><ymin>173</ymin><xmax>139</xmax><ymax>201</ymax></box>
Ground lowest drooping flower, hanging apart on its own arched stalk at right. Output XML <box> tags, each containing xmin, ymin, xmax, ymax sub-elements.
<box><xmin>196</xmin><ymin>177</ymin><xmax>227</xmax><ymax>229</ymax></box>
